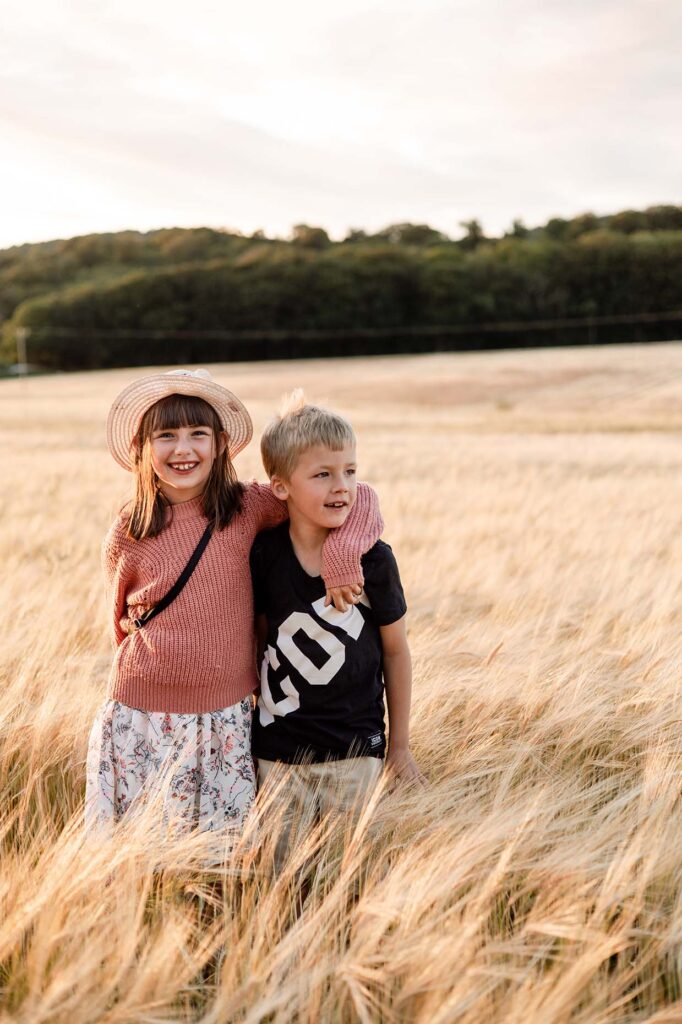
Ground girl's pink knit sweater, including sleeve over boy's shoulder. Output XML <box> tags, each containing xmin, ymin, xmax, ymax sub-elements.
<box><xmin>102</xmin><ymin>483</ymin><xmax>383</xmax><ymax>714</ymax></box>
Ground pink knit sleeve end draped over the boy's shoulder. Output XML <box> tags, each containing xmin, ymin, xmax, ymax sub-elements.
<box><xmin>322</xmin><ymin>483</ymin><xmax>384</xmax><ymax>589</ymax></box>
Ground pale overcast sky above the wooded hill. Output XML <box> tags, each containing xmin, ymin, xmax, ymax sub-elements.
<box><xmin>0</xmin><ymin>0</ymin><xmax>682</xmax><ymax>246</ymax></box>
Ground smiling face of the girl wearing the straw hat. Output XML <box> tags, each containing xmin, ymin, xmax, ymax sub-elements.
<box><xmin>150</xmin><ymin>425</ymin><xmax>225</xmax><ymax>505</ymax></box>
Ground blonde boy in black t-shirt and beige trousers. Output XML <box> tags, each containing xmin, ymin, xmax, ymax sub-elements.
<box><xmin>251</xmin><ymin>391</ymin><xmax>423</xmax><ymax>851</ymax></box>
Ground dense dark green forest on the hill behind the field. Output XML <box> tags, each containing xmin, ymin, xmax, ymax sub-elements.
<box><xmin>0</xmin><ymin>206</ymin><xmax>682</xmax><ymax>370</ymax></box>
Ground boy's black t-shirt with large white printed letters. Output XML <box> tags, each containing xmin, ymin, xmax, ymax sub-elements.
<box><xmin>251</xmin><ymin>522</ymin><xmax>407</xmax><ymax>764</ymax></box>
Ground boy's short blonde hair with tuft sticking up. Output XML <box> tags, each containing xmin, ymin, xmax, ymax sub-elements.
<box><xmin>260</xmin><ymin>388</ymin><xmax>355</xmax><ymax>480</ymax></box>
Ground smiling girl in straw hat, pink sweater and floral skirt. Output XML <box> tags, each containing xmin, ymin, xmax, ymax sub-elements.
<box><xmin>85</xmin><ymin>370</ymin><xmax>382</xmax><ymax>833</ymax></box>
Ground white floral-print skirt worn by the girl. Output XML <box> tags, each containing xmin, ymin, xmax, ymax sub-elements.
<box><xmin>85</xmin><ymin>697</ymin><xmax>255</xmax><ymax>835</ymax></box>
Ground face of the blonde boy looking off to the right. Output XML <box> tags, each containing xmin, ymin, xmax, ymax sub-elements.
<box><xmin>271</xmin><ymin>444</ymin><xmax>357</xmax><ymax>529</ymax></box>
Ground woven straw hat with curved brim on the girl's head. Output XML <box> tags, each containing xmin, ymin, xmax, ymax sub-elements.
<box><xmin>106</xmin><ymin>370</ymin><xmax>253</xmax><ymax>470</ymax></box>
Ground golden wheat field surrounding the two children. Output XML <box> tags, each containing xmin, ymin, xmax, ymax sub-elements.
<box><xmin>0</xmin><ymin>344</ymin><xmax>682</xmax><ymax>1024</ymax></box>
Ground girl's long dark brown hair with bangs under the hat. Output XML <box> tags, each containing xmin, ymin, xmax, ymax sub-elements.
<box><xmin>128</xmin><ymin>394</ymin><xmax>244</xmax><ymax>541</ymax></box>
